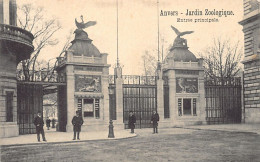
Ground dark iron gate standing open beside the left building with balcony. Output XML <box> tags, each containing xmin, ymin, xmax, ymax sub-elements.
<box><xmin>17</xmin><ymin>71</ymin><xmax>67</xmax><ymax>135</ymax></box>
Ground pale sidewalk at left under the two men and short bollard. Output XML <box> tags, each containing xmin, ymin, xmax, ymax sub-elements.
<box><xmin>0</xmin><ymin>130</ymin><xmax>136</xmax><ymax>146</ymax></box>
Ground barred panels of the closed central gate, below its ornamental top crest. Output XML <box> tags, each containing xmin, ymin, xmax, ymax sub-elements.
<box><xmin>123</xmin><ymin>85</ymin><xmax>157</xmax><ymax>128</ymax></box>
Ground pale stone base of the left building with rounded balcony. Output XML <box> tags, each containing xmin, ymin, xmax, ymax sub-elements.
<box><xmin>0</xmin><ymin>123</ymin><xmax>19</xmax><ymax>138</ymax></box>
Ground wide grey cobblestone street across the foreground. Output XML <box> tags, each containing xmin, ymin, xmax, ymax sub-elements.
<box><xmin>1</xmin><ymin>128</ymin><xmax>260</xmax><ymax>162</ymax></box>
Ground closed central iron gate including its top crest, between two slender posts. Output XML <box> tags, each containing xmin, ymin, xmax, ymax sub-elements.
<box><xmin>123</xmin><ymin>76</ymin><xmax>157</xmax><ymax>128</ymax></box>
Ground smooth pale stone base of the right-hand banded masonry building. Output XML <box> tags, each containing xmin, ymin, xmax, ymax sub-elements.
<box><xmin>245</xmin><ymin>108</ymin><xmax>260</xmax><ymax>124</ymax></box>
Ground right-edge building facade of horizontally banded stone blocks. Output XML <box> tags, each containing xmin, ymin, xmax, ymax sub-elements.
<box><xmin>239</xmin><ymin>0</ymin><xmax>260</xmax><ymax>123</ymax></box>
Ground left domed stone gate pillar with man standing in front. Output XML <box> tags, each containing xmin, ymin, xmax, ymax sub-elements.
<box><xmin>56</xmin><ymin>18</ymin><xmax>110</xmax><ymax>132</ymax></box>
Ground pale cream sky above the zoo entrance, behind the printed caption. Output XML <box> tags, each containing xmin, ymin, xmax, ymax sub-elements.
<box><xmin>17</xmin><ymin>0</ymin><xmax>243</xmax><ymax>75</ymax></box>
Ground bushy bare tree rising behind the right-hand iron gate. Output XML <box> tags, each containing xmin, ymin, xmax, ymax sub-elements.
<box><xmin>200</xmin><ymin>38</ymin><xmax>242</xmax><ymax>83</ymax></box>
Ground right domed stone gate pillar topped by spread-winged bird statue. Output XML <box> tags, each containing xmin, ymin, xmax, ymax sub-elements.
<box><xmin>162</xmin><ymin>27</ymin><xmax>205</xmax><ymax>126</ymax></box>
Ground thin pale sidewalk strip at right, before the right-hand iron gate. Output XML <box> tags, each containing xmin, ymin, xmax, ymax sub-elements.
<box><xmin>182</xmin><ymin>124</ymin><xmax>260</xmax><ymax>135</ymax></box>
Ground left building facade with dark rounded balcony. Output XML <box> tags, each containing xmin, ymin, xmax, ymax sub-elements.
<box><xmin>0</xmin><ymin>0</ymin><xmax>33</xmax><ymax>137</ymax></box>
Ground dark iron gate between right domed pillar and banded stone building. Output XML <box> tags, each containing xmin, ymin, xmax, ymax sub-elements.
<box><xmin>205</xmin><ymin>78</ymin><xmax>242</xmax><ymax>124</ymax></box>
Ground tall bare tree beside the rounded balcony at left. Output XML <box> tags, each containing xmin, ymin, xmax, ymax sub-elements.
<box><xmin>18</xmin><ymin>4</ymin><xmax>61</xmax><ymax>81</ymax></box>
